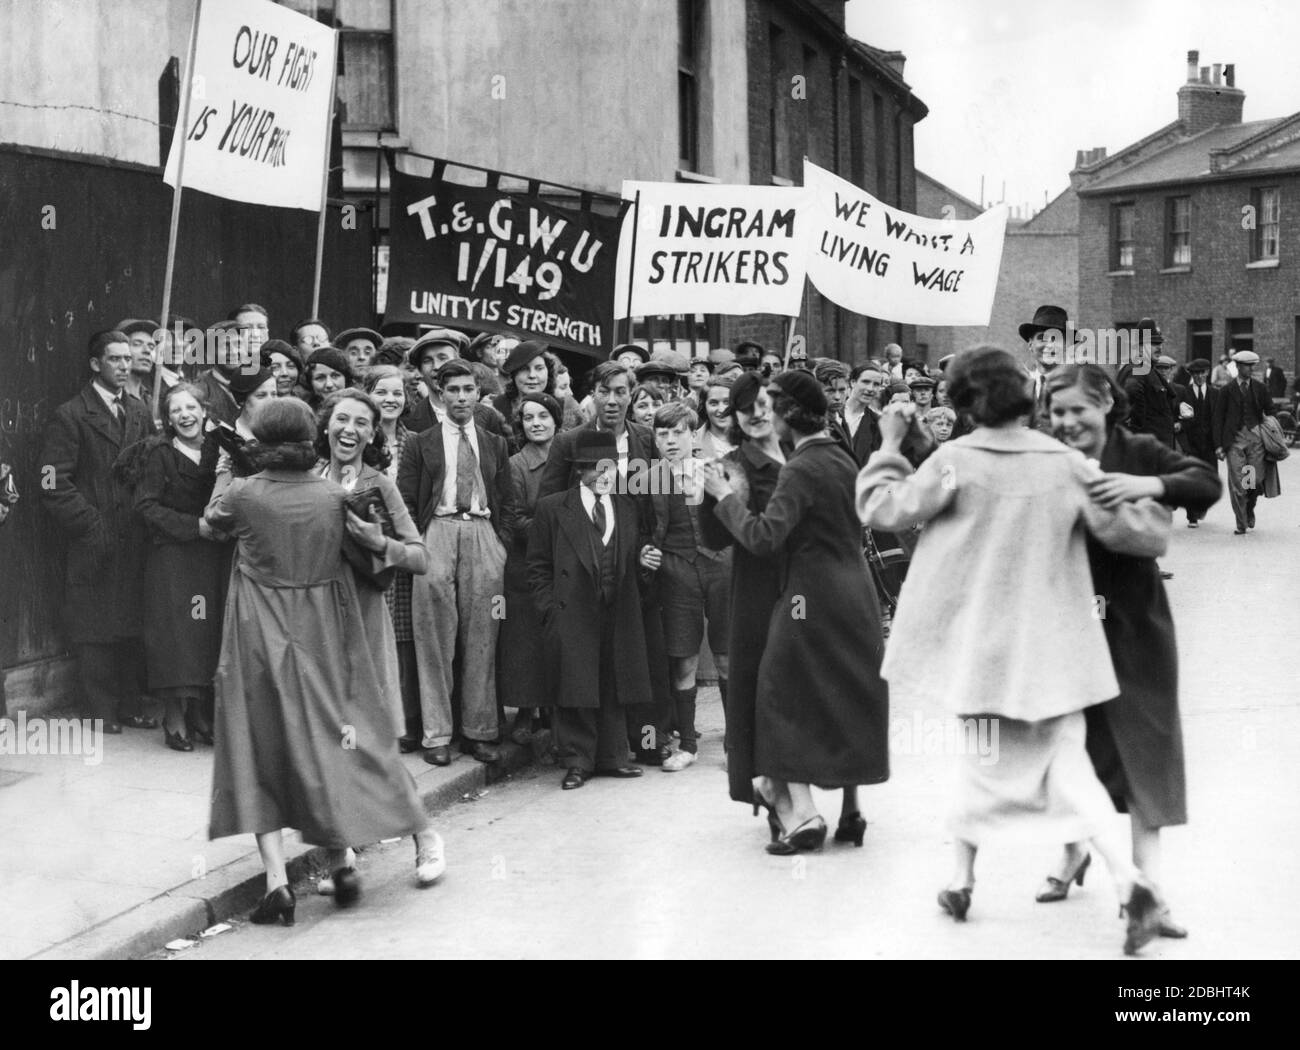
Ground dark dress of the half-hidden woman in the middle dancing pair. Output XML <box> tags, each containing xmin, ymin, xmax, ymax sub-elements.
<box><xmin>699</xmin><ymin>441</ymin><xmax>781</xmax><ymax>806</ymax></box>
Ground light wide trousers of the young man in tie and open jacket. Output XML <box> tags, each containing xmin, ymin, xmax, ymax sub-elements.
<box><xmin>411</xmin><ymin>517</ymin><xmax>506</xmax><ymax>747</ymax></box>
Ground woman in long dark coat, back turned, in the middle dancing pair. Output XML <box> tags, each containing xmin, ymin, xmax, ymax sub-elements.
<box><xmin>705</xmin><ymin>370</ymin><xmax>889</xmax><ymax>854</ymax></box>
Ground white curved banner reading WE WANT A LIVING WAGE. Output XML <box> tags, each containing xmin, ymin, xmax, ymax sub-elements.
<box><xmin>803</xmin><ymin>160</ymin><xmax>1006</xmax><ymax>325</ymax></box>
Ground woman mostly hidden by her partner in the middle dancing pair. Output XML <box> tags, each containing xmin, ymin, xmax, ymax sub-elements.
<box><xmin>699</xmin><ymin>373</ymin><xmax>785</xmax><ymax>810</ymax></box>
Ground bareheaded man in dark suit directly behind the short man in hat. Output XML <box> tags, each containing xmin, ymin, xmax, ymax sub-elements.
<box><xmin>538</xmin><ymin>361</ymin><xmax>672</xmax><ymax>765</ymax></box>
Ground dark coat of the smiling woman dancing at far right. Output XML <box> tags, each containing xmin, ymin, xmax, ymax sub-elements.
<box><xmin>1087</xmin><ymin>426</ymin><xmax>1222</xmax><ymax>828</ymax></box>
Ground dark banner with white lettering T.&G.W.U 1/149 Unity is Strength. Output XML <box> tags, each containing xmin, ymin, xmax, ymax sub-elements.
<box><xmin>384</xmin><ymin>166</ymin><xmax>621</xmax><ymax>357</ymax></box>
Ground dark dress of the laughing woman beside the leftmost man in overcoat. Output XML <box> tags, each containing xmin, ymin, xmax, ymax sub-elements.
<box><xmin>135</xmin><ymin>441</ymin><xmax>230</xmax><ymax>695</ymax></box>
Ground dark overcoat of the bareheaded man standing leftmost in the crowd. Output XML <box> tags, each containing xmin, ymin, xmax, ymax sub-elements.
<box><xmin>40</xmin><ymin>383</ymin><xmax>153</xmax><ymax>645</ymax></box>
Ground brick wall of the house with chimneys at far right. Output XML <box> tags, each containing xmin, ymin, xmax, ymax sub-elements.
<box><xmin>1079</xmin><ymin>174</ymin><xmax>1300</xmax><ymax>377</ymax></box>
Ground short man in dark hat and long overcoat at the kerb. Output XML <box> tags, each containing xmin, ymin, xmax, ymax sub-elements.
<box><xmin>528</xmin><ymin>426</ymin><xmax>659</xmax><ymax>791</ymax></box>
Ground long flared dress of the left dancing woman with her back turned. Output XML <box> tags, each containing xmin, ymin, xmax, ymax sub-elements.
<box><xmin>207</xmin><ymin>469</ymin><xmax>429</xmax><ymax>849</ymax></box>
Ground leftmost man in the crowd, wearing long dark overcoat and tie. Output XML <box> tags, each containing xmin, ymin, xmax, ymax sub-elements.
<box><xmin>40</xmin><ymin>331</ymin><xmax>156</xmax><ymax>733</ymax></box>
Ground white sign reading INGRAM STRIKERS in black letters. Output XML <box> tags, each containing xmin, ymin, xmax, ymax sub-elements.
<box><xmin>614</xmin><ymin>182</ymin><xmax>810</xmax><ymax>317</ymax></box>
